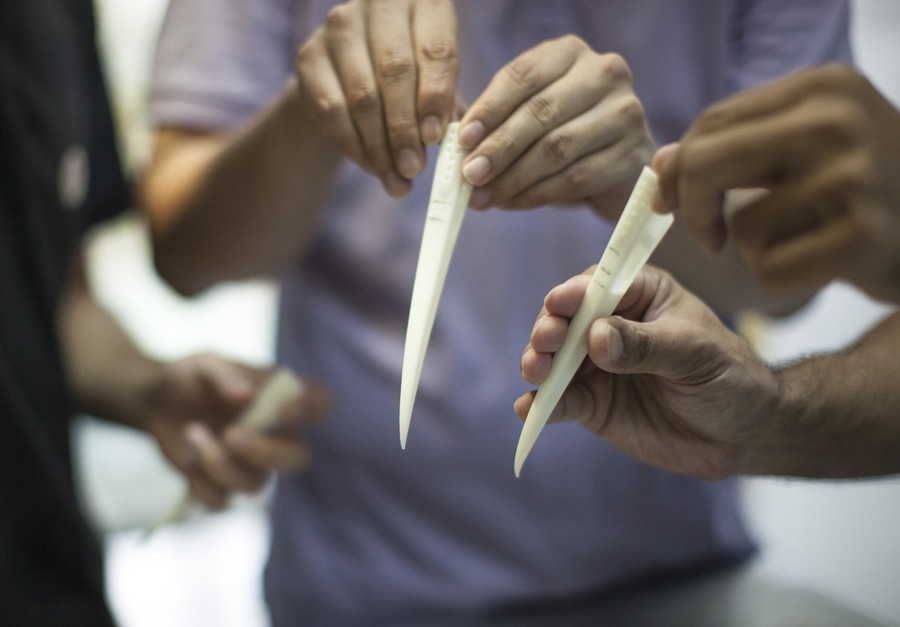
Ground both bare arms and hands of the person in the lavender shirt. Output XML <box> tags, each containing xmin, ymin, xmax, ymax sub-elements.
<box><xmin>142</xmin><ymin>0</ymin><xmax>810</xmax><ymax>315</ymax></box>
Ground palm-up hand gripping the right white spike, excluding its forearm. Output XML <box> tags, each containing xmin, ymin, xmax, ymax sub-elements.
<box><xmin>515</xmin><ymin>266</ymin><xmax>779</xmax><ymax>479</ymax></box>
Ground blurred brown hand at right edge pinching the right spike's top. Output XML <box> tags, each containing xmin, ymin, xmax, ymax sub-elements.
<box><xmin>653</xmin><ymin>66</ymin><xmax>900</xmax><ymax>301</ymax></box>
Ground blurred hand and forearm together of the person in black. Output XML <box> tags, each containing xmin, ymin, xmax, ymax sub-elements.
<box><xmin>58</xmin><ymin>263</ymin><xmax>330</xmax><ymax>508</ymax></box>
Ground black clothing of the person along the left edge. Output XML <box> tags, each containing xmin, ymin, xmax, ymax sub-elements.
<box><xmin>0</xmin><ymin>0</ymin><xmax>127</xmax><ymax>627</ymax></box>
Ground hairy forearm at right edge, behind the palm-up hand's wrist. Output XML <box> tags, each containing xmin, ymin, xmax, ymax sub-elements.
<box><xmin>744</xmin><ymin>314</ymin><xmax>900</xmax><ymax>478</ymax></box>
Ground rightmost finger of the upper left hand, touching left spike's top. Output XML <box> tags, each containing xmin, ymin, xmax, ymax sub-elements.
<box><xmin>413</xmin><ymin>0</ymin><xmax>459</xmax><ymax>146</ymax></box>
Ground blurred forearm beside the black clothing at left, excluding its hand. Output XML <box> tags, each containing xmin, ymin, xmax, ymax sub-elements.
<box><xmin>58</xmin><ymin>257</ymin><xmax>163</xmax><ymax>429</ymax></box>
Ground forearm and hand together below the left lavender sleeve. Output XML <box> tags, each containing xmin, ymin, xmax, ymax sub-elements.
<box><xmin>142</xmin><ymin>0</ymin><xmax>458</xmax><ymax>294</ymax></box>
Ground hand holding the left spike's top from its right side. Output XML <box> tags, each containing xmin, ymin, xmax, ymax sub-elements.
<box><xmin>459</xmin><ymin>35</ymin><xmax>654</xmax><ymax>221</ymax></box>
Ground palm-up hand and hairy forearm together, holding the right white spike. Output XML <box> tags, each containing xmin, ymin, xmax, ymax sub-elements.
<box><xmin>515</xmin><ymin>266</ymin><xmax>900</xmax><ymax>479</ymax></box>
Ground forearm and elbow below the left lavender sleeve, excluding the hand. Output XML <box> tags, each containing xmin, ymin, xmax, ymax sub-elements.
<box><xmin>143</xmin><ymin>80</ymin><xmax>341</xmax><ymax>293</ymax></box>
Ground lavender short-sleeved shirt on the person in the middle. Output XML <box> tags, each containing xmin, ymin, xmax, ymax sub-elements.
<box><xmin>151</xmin><ymin>0</ymin><xmax>849</xmax><ymax>625</ymax></box>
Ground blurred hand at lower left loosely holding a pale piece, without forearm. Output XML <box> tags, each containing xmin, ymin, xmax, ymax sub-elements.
<box><xmin>147</xmin><ymin>355</ymin><xmax>330</xmax><ymax>508</ymax></box>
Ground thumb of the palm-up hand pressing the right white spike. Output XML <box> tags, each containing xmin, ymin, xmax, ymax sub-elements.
<box><xmin>588</xmin><ymin>316</ymin><xmax>691</xmax><ymax>377</ymax></box>
